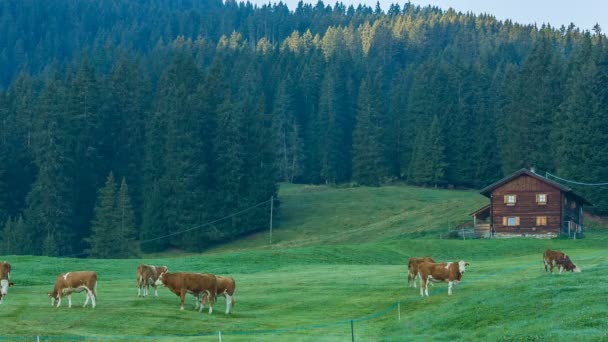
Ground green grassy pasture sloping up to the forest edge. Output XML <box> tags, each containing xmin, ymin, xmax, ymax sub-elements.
<box><xmin>0</xmin><ymin>186</ymin><xmax>608</xmax><ymax>341</ymax></box>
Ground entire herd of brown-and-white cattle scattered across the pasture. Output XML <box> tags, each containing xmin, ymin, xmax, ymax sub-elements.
<box><xmin>0</xmin><ymin>250</ymin><xmax>581</xmax><ymax>314</ymax></box>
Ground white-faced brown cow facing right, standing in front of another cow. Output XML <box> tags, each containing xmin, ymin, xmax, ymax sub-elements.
<box><xmin>418</xmin><ymin>260</ymin><xmax>469</xmax><ymax>297</ymax></box>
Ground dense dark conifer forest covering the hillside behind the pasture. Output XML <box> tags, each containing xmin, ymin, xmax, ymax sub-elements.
<box><xmin>0</xmin><ymin>0</ymin><xmax>608</xmax><ymax>258</ymax></box>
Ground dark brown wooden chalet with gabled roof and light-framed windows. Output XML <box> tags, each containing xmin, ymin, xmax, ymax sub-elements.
<box><xmin>471</xmin><ymin>169</ymin><xmax>590</xmax><ymax>238</ymax></box>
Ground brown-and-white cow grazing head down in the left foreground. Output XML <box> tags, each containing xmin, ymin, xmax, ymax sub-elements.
<box><xmin>48</xmin><ymin>271</ymin><xmax>97</xmax><ymax>309</ymax></box>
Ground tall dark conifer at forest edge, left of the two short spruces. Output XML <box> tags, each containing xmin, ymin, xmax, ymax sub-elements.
<box><xmin>24</xmin><ymin>79</ymin><xmax>75</xmax><ymax>256</ymax></box>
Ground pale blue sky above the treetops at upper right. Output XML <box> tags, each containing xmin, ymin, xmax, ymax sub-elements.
<box><xmin>250</xmin><ymin>0</ymin><xmax>608</xmax><ymax>33</ymax></box>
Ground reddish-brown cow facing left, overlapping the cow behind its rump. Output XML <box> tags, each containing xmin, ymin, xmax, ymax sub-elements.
<box><xmin>156</xmin><ymin>272</ymin><xmax>217</xmax><ymax>314</ymax></box>
